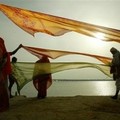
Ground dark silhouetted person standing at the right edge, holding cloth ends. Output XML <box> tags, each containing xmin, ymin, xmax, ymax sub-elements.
<box><xmin>110</xmin><ymin>47</ymin><xmax>120</xmax><ymax>99</ymax></box>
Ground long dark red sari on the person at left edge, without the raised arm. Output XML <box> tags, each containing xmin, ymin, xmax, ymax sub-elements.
<box><xmin>0</xmin><ymin>38</ymin><xmax>11</xmax><ymax>112</ymax></box>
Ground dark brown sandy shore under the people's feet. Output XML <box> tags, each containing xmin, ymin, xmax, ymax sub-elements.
<box><xmin>0</xmin><ymin>96</ymin><xmax>120</xmax><ymax>120</ymax></box>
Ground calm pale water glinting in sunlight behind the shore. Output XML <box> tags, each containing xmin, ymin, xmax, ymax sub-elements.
<box><xmin>12</xmin><ymin>80</ymin><xmax>115</xmax><ymax>97</ymax></box>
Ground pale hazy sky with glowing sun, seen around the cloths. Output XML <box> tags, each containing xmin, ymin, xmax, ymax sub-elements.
<box><xmin>0</xmin><ymin>0</ymin><xmax>120</xmax><ymax>79</ymax></box>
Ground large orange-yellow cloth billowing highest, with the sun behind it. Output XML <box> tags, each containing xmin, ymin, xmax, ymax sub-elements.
<box><xmin>0</xmin><ymin>4</ymin><xmax>120</xmax><ymax>42</ymax></box>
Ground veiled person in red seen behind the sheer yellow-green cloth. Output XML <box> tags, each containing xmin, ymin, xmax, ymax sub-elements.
<box><xmin>33</xmin><ymin>56</ymin><xmax>52</xmax><ymax>99</ymax></box>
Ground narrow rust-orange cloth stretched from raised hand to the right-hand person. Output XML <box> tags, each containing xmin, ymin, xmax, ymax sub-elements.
<box><xmin>22</xmin><ymin>46</ymin><xmax>112</xmax><ymax>65</ymax></box>
